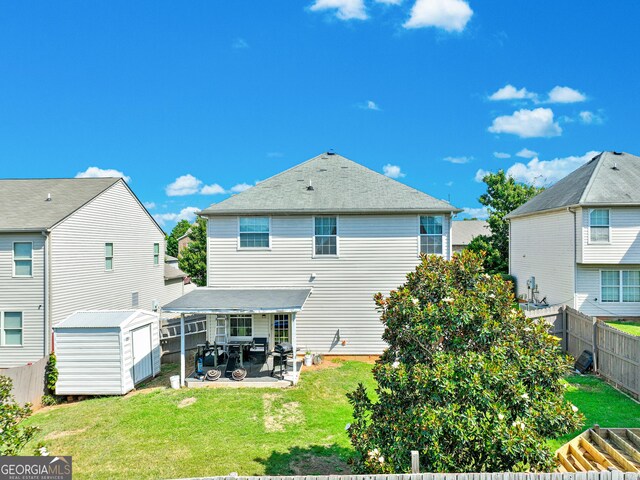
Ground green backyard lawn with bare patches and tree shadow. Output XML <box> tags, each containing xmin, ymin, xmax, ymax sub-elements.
<box><xmin>27</xmin><ymin>362</ymin><xmax>640</xmax><ymax>479</ymax></box>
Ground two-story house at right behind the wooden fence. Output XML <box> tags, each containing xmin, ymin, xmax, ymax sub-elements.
<box><xmin>507</xmin><ymin>152</ymin><xmax>640</xmax><ymax>317</ymax></box>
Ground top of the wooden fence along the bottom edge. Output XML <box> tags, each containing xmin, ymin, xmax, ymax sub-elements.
<box><xmin>179</xmin><ymin>470</ymin><xmax>640</xmax><ymax>480</ymax></box>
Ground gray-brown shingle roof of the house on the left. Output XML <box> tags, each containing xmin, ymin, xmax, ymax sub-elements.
<box><xmin>0</xmin><ymin>178</ymin><xmax>120</xmax><ymax>231</ymax></box>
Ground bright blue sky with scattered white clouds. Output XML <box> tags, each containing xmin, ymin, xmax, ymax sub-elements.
<box><xmin>0</xmin><ymin>0</ymin><xmax>640</xmax><ymax>230</ymax></box>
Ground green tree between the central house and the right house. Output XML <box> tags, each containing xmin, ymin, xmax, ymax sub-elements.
<box><xmin>467</xmin><ymin>170</ymin><xmax>543</xmax><ymax>273</ymax></box>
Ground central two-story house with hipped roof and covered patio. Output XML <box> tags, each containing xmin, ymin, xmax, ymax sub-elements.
<box><xmin>163</xmin><ymin>153</ymin><xmax>460</xmax><ymax>374</ymax></box>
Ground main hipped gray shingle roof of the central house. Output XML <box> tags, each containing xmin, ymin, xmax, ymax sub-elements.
<box><xmin>201</xmin><ymin>153</ymin><xmax>460</xmax><ymax>215</ymax></box>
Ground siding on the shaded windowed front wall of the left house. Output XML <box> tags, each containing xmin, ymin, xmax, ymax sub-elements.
<box><xmin>0</xmin><ymin>233</ymin><xmax>45</xmax><ymax>368</ymax></box>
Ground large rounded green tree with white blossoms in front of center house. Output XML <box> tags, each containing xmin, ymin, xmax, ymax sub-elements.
<box><xmin>348</xmin><ymin>251</ymin><xmax>582</xmax><ymax>474</ymax></box>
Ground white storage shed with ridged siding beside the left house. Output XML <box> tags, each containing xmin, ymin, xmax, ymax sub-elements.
<box><xmin>53</xmin><ymin>310</ymin><xmax>160</xmax><ymax>395</ymax></box>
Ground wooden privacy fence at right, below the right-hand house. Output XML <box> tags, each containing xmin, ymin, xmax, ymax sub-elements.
<box><xmin>525</xmin><ymin>305</ymin><xmax>640</xmax><ymax>398</ymax></box>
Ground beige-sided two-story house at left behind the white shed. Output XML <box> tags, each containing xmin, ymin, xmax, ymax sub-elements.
<box><xmin>0</xmin><ymin>178</ymin><xmax>168</xmax><ymax>368</ymax></box>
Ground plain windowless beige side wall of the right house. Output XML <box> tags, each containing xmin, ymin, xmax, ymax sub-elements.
<box><xmin>509</xmin><ymin>210</ymin><xmax>580</xmax><ymax>306</ymax></box>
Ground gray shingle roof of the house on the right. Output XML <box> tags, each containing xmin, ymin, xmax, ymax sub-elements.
<box><xmin>507</xmin><ymin>152</ymin><xmax>640</xmax><ymax>218</ymax></box>
